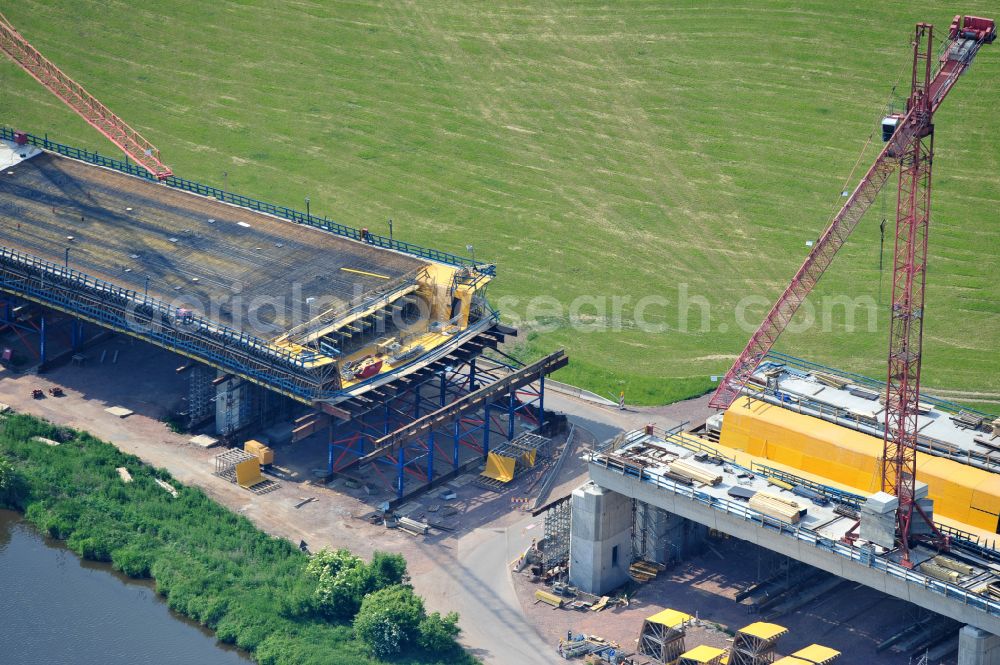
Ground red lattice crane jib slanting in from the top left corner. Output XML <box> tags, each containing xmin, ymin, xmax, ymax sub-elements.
<box><xmin>0</xmin><ymin>14</ymin><xmax>173</xmax><ymax>180</ymax></box>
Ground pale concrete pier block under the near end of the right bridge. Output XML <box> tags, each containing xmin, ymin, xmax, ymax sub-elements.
<box><xmin>569</xmin><ymin>483</ymin><xmax>632</xmax><ymax>594</ymax></box>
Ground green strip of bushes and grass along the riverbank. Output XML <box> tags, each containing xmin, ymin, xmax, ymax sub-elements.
<box><xmin>0</xmin><ymin>415</ymin><xmax>475</xmax><ymax>665</ymax></box>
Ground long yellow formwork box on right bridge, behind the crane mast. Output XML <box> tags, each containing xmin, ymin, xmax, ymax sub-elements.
<box><xmin>719</xmin><ymin>398</ymin><xmax>1000</xmax><ymax>534</ymax></box>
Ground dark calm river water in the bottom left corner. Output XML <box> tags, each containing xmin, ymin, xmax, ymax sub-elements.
<box><xmin>0</xmin><ymin>510</ymin><xmax>252</xmax><ymax>665</ymax></box>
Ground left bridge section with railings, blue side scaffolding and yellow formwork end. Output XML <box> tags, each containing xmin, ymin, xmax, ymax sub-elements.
<box><xmin>0</xmin><ymin>132</ymin><xmax>503</xmax><ymax>405</ymax></box>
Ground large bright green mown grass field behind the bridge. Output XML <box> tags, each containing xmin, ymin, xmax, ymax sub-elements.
<box><xmin>0</xmin><ymin>0</ymin><xmax>1000</xmax><ymax>409</ymax></box>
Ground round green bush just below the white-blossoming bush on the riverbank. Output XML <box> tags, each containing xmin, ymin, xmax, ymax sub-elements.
<box><xmin>354</xmin><ymin>584</ymin><xmax>425</xmax><ymax>658</ymax></box>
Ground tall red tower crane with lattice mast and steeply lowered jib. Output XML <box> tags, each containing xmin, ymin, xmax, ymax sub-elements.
<box><xmin>709</xmin><ymin>16</ymin><xmax>996</xmax><ymax>564</ymax></box>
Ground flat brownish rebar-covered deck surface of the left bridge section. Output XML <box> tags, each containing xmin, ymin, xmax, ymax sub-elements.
<box><xmin>0</xmin><ymin>152</ymin><xmax>428</xmax><ymax>339</ymax></box>
